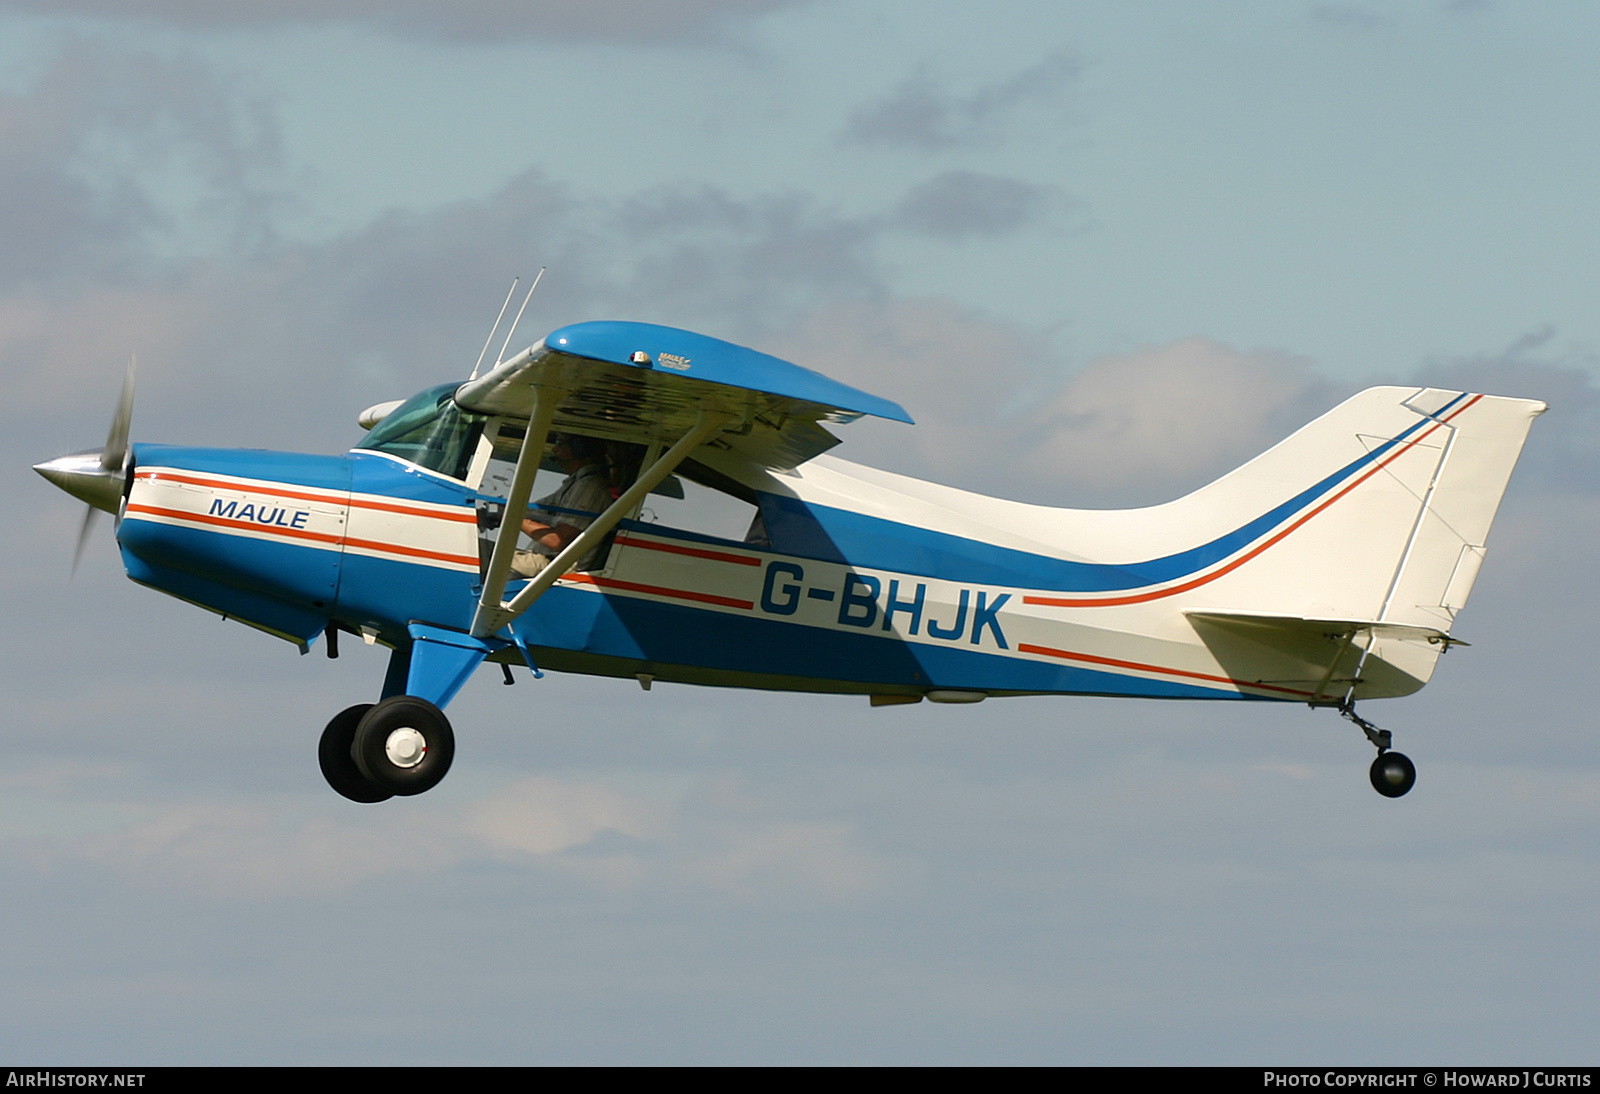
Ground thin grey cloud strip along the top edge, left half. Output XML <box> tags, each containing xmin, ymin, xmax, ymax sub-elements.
<box><xmin>0</xmin><ymin>0</ymin><xmax>805</xmax><ymax>43</ymax></box>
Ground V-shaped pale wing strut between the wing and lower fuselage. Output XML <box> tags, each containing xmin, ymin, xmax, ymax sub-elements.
<box><xmin>472</xmin><ymin>406</ymin><xmax>733</xmax><ymax>638</ymax></box>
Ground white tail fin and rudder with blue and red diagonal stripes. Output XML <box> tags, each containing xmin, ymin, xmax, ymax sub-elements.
<box><xmin>1160</xmin><ymin>387</ymin><xmax>1546</xmax><ymax>701</ymax></box>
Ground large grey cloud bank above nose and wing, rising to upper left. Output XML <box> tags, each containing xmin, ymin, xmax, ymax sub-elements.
<box><xmin>0</xmin><ymin>45</ymin><xmax>1059</xmax><ymax>463</ymax></box>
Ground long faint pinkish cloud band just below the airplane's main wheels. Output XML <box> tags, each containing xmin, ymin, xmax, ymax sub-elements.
<box><xmin>0</xmin><ymin>761</ymin><xmax>885</xmax><ymax>904</ymax></box>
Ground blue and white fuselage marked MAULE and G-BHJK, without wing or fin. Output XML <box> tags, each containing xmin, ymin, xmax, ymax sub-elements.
<box><xmin>118</xmin><ymin>383</ymin><xmax>1472</xmax><ymax>702</ymax></box>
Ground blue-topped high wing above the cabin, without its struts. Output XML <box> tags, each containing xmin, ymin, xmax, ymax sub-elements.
<box><xmin>456</xmin><ymin>321</ymin><xmax>912</xmax><ymax>470</ymax></box>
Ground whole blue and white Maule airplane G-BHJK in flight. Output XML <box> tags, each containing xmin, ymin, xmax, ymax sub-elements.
<box><xmin>35</xmin><ymin>316</ymin><xmax>1546</xmax><ymax>803</ymax></box>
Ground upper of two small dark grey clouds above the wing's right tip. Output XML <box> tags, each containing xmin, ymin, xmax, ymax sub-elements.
<box><xmin>842</xmin><ymin>53</ymin><xmax>1080</xmax><ymax>152</ymax></box>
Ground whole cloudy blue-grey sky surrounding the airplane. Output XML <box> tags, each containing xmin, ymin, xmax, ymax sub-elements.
<box><xmin>0</xmin><ymin>0</ymin><xmax>1600</xmax><ymax>1065</ymax></box>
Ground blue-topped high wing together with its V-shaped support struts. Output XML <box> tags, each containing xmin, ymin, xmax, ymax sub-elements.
<box><xmin>456</xmin><ymin>321</ymin><xmax>910</xmax><ymax>643</ymax></box>
